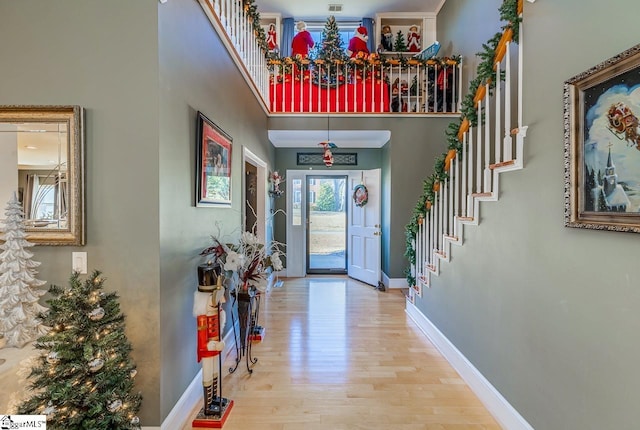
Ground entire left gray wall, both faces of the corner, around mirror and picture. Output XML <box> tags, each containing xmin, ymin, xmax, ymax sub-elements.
<box><xmin>0</xmin><ymin>0</ymin><xmax>274</xmax><ymax>426</ymax></box>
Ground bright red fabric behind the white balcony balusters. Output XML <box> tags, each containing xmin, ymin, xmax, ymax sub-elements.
<box><xmin>269</xmin><ymin>79</ymin><xmax>389</xmax><ymax>113</ymax></box>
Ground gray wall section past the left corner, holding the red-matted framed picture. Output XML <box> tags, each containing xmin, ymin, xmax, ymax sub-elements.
<box><xmin>158</xmin><ymin>0</ymin><xmax>274</xmax><ymax>419</ymax></box>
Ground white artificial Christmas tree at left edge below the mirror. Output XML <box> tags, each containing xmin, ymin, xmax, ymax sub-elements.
<box><xmin>0</xmin><ymin>193</ymin><xmax>49</xmax><ymax>348</ymax></box>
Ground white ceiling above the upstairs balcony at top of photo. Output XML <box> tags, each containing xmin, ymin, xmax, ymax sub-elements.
<box><xmin>256</xmin><ymin>0</ymin><xmax>445</xmax><ymax>20</ymax></box>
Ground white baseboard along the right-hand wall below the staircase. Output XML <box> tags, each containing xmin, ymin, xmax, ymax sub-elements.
<box><xmin>405</xmin><ymin>301</ymin><xmax>533</xmax><ymax>430</ymax></box>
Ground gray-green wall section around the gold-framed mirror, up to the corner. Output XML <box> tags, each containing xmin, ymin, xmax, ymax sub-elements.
<box><xmin>0</xmin><ymin>0</ymin><xmax>160</xmax><ymax>424</ymax></box>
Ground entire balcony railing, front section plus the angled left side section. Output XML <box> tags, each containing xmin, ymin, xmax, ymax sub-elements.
<box><xmin>199</xmin><ymin>0</ymin><xmax>462</xmax><ymax>114</ymax></box>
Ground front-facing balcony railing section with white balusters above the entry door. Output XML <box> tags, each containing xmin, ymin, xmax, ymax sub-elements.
<box><xmin>269</xmin><ymin>54</ymin><xmax>461</xmax><ymax>113</ymax></box>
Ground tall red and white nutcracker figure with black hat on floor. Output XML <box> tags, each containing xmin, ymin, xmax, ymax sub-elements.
<box><xmin>193</xmin><ymin>263</ymin><xmax>233</xmax><ymax>428</ymax></box>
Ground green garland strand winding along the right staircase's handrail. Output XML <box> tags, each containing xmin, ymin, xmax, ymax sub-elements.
<box><xmin>404</xmin><ymin>0</ymin><xmax>522</xmax><ymax>287</ymax></box>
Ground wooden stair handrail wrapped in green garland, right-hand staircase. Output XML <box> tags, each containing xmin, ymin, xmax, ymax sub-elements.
<box><xmin>405</xmin><ymin>0</ymin><xmax>523</xmax><ymax>287</ymax></box>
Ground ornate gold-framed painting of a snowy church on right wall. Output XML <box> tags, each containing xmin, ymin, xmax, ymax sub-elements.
<box><xmin>564</xmin><ymin>45</ymin><xmax>640</xmax><ymax>233</ymax></box>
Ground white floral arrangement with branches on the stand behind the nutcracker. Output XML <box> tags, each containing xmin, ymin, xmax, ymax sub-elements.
<box><xmin>200</xmin><ymin>231</ymin><xmax>284</xmax><ymax>292</ymax></box>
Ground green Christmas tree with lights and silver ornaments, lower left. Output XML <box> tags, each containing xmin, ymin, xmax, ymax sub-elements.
<box><xmin>18</xmin><ymin>271</ymin><xmax>142</xmax><ymax>430</ymax></box>
